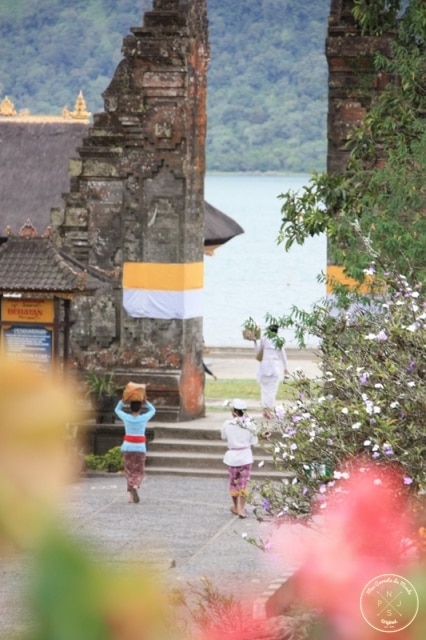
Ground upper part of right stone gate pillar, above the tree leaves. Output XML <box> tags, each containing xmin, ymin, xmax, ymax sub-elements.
<box><xmin>325</xmin><ymin>0</ymin><xmax>396</xmax><ymax>173</ymax></box>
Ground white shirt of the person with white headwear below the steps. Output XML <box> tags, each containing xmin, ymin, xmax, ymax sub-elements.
<box><xmin>221</xmin><ymin>417</ymin><xmax>258</xmax><ymax>467</ymax></box>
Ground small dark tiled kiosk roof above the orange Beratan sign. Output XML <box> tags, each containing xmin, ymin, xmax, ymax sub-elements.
<box><xmin>0</xmin><ymin>237</ymin><xmax>112</xmax><ymax>293</ymax></box>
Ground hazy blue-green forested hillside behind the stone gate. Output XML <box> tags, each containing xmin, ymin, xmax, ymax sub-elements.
<box><xmin>0</xmin><ymin>0</ymin><xmax>330</xmax><ymax>172</ymax></box>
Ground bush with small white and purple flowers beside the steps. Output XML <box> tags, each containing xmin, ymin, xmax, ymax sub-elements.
<box><xmin>252</xmin><ymin>270</ymin><xmax>426</xmax><ymax>540</ymax></box>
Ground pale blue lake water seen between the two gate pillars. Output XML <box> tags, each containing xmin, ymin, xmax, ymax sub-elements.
<box><xmin>203</xmin><ymin>175</ymin><xmax>326</xmax><ymax>348</ymax></box>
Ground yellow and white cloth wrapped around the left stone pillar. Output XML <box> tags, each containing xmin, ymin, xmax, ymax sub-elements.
<box><xmin>123</xmin><ymin>262</ymin><xmax>204</xmax><ymax>320</ymax></box>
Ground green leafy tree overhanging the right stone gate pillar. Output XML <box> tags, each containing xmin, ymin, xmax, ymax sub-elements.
<box><xmin>279</xmin><ymin>0</ymin><xmax>426</xmax><ymax>280</ymax></box>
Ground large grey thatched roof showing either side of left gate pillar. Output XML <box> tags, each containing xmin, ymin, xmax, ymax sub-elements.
<box><xmin>0</xmin><ymin>117</ymin><xmax>244</xmax><ymax>253</ymax></box>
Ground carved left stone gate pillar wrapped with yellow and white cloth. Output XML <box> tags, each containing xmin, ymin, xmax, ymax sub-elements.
<box><xmin>56</xmin><ymin>0</ymin><xmax>209</xmax><ymax>420</ymax></box>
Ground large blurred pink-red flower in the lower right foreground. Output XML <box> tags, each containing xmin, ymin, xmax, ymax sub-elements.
<box><xmin>295</xmin><ymin>462</ymin><xmax>410</xmax><ymax>640</ymax></box>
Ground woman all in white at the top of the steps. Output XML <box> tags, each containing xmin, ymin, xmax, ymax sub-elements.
<box><xmin>254</xmin><ymin>324</ymin><xmax>289</xmax><ymax>418</ymax></box>
